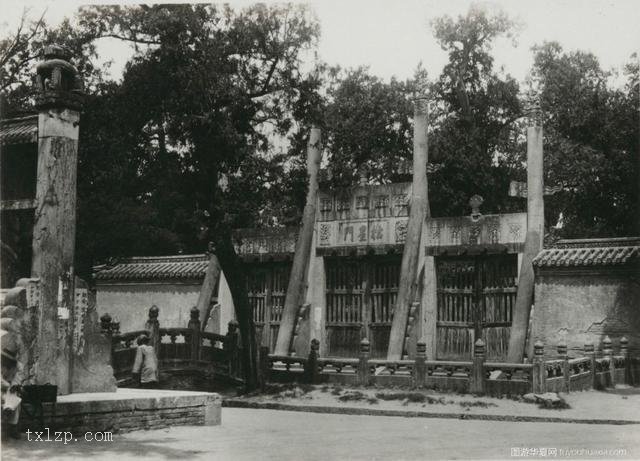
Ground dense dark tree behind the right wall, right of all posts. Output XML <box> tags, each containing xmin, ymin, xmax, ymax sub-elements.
<box><xmin>531</xmin><ymin>42</ymin><xmax>639</xmax><ymax>238</ymax></box>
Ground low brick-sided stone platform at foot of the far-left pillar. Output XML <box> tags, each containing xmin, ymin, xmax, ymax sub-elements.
<box><xmin>20</xmin><ymin>389</ymin><xmax>222</xmax><ymax>433</ymax></box>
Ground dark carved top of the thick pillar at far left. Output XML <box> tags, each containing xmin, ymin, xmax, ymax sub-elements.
<box><xmin>36</xmin><ymin>45</ymin><xmax>84</xmax><ymax>111</ymax></box>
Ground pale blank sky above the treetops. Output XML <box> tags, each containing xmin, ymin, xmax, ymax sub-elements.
<box><xmin>0</xmin><ymin>0</ymin><xmax>640</xmax><ymax>84</ymax></box>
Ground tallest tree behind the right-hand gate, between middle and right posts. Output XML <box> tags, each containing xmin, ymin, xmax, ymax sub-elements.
<box><xmin>429</xmin><ymin>7</ymin><xmax>522</xmax><ymax>216</ymax></box>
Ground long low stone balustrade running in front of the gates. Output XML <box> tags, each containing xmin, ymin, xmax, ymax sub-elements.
<box><xmin>264</xmin><ymin>337</ymin><xmax>637</xmax><ymax>395</ymax></box>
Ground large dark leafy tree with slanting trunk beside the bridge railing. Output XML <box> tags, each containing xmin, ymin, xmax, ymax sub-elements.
<box><xmin>74</xmin><ymin>5</ymin><xmax>318</xmax><ymax>387</ymax></box>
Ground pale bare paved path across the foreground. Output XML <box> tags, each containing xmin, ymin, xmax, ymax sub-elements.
<box><xmin>2</xmin><ymin>408</ymin><xmax>640</xmax><ymax>461</ymax></box>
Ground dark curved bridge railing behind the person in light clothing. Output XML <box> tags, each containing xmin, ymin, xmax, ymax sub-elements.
<box><xmin>100</xmin><ymin>306</ymin><xmax>242</xmax><ymax>385</ymax></box>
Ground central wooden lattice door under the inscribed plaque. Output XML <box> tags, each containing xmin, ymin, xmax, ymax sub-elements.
<box><xmin>325</xmin><ymin>256</ymin><xmax>400</xmax><ymax>358</ymax></box>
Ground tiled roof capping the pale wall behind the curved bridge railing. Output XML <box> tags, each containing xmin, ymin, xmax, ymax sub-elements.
<box><xmin>94</xmin><ymin>254</ymin><xmax>209</xmax><ymax>281</ymax></box>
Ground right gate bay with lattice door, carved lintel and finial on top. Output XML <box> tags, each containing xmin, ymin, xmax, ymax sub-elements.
<box><xmin>423</xmin><ymin>196</ymin><xmax>527</xmax><ymax>360</ymax></box>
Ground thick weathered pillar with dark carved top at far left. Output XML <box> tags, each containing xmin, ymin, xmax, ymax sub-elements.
<box><xmin>31</xmin><ymin>46</ymin><xmax>83</xmax><ymax>394</ymax></box>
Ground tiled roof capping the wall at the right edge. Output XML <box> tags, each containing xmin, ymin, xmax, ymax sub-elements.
<box><xmin>533</xmin><ymin>238</ymin><xmax>640</xmax><ymax>268</ymax></box>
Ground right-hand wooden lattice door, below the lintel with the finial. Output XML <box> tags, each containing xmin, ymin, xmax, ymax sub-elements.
<box><xmin>436</xmin><ymin>255</ymin><xmax>518</xmax><ymax>360</ymax></box>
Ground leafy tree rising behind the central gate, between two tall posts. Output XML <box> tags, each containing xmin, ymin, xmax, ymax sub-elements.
<box><xmin>321</xmin><ymin>67</ymin><xmax>416</xmax><ymax>186</ymax></box>
